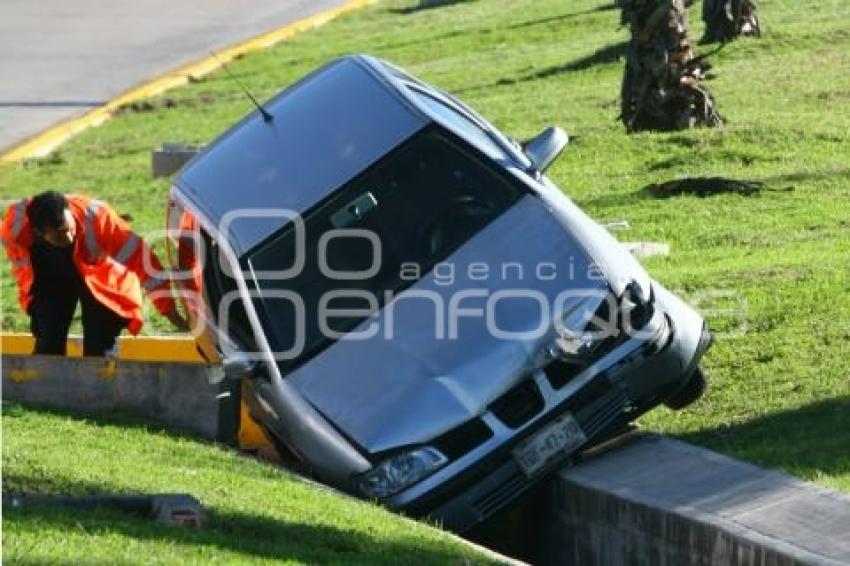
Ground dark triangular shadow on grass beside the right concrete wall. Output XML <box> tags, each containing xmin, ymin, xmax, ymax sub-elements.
<box><xmin>678</xmin><ymin>396</ymin><xmax>850</xmax><ymax>484</ymax></box>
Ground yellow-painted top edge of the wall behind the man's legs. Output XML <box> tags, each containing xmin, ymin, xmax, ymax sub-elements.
<box><xmin>0</xmin><ymin>332</ymin><xmax>206</xmax><ymax>364</ymax></box>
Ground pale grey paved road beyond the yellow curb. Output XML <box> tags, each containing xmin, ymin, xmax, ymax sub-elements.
<box><xmin>0</xmin><ymin>0</ymin><xmax>344</xmax><ymax>151</ymax></box>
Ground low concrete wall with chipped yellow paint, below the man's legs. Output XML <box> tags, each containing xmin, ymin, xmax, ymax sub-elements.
<box><xmin>2</xmin><ymin>355</ymin><xmax>225</xmax><ymax>440</ymax></box>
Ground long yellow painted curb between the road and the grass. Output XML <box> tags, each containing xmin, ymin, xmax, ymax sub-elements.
<box><xmin>0</xmin><ymin>0</ymin><xmax>371</xmax><ymax>163</ymax></box>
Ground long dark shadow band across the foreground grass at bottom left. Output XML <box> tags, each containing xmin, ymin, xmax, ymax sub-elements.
<box><xmin>3</xmin><ymin>507</ymin><xmax>470</xmax><ymax>564</ymax></box>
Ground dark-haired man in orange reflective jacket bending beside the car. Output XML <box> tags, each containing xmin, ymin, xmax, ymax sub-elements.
<box><xmin>0</xmin><ymin>191</ymin><xmax>186</xmax><ymax>356</ymax></box>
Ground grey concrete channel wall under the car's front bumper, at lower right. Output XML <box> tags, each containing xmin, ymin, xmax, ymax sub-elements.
<box><xmin>548</xmin><ymin>435</ymin><xmax>850</xmax><ymax>566</ymax></box>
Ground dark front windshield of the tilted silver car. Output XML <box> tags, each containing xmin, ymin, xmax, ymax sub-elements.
<box><xmin>245</xmin><ymin>126</ymin><xmax>523</xmax><ymax>369</ymax></box>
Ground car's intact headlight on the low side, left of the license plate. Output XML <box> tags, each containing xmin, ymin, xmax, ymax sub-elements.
<box><xmin>358</xmin><ymin>447</ymin><xmax>448</xmax><ymax>498</ymax></box>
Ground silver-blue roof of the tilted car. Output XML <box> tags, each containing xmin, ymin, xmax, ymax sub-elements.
<box><xmin>178</xmin><ymin>55</ymin><xmax>432</xmax><ymax>255</ymax></box>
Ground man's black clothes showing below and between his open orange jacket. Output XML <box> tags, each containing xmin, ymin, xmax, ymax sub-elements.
<box><xmin>29</xmin><ymin>241</ymin><xmax>128</xmax><ymax>356</ymax></box>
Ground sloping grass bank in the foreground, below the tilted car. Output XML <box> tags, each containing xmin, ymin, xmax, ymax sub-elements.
<box><xmin>3</xmin><ymin>405</ymin><xmax>492</xmax><ymax>564</ymax></box>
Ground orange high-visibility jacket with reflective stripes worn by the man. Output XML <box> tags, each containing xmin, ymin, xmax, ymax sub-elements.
<box><xmin>0</xmin><ymin>195</ymin><xmax>174</xmax><ymax>334</ymax></box>
